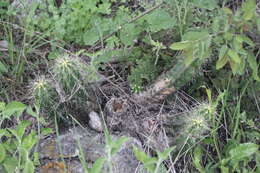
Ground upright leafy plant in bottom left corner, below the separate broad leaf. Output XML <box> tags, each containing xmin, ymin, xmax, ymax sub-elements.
<box><xmin>0</xmin><ymin>121</ymin><xmax>38</xmax><ymax>173</ymax></box>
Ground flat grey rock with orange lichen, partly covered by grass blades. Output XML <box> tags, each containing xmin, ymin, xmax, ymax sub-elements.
<box><xmin>38</xmin><ymin>128</ymin><xmax>143</xmax><ymax>173</ymax></box>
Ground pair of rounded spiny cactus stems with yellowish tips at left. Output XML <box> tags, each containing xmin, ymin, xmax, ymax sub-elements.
<box><xmin>30</xmin><ymin>55</ymin><xmax>97</xmax><ymax>117</ymax></box>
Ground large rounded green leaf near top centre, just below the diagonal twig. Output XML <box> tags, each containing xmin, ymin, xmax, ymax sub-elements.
<box><xmin>142</xmin><ymin>9</ymin><xmax>176</xmax><ymax>32</ymax></box>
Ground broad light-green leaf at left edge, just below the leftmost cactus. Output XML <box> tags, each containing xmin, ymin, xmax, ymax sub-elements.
<box><xmin>2</xmin><ymin>101</ymin><xmax>26</xmax><ymax>118</ymax></box>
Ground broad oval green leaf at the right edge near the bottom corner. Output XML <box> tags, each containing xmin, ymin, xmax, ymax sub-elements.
<box><xmin>229</xmin><ymin>143</ymin><xmax>259</xmax><ymax>162</ymax></box>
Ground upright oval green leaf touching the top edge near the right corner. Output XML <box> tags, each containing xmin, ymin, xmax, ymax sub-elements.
<box><xmin>242</xmin><ymin>0</ymin><xmax>256</xmax><ymax>20</ymax></box>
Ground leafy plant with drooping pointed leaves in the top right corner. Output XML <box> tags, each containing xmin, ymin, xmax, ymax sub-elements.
<box><xmin>212</xmin><ymin>0</ymin><xmax>260</xmax><ymax>81</ymax></box>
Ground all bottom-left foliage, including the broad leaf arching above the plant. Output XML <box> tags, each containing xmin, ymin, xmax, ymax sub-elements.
<box><xmin>0</xmin><ymin>101</ymin><xmax>51</xmax><ymax>173</ymax></box>
